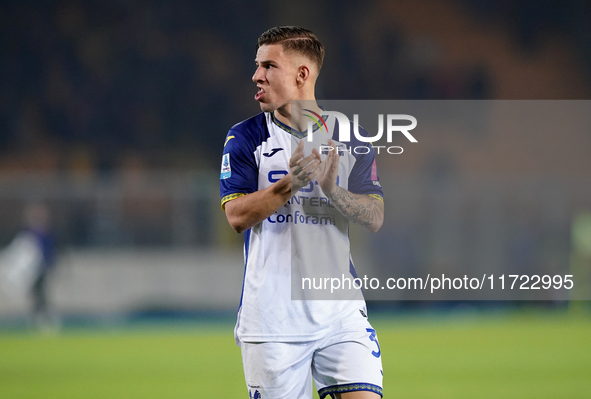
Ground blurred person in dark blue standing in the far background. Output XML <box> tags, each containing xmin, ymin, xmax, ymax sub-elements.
<box><xmin>0</xmin><ymin>203</ymin><xmax>57</xmax><ymax>331</ymax></box>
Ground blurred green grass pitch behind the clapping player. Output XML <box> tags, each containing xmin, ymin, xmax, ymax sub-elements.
<box><xmin>0</xmin><ymin>313</ymin><xmax>591</xmax><ymax>399</ymax></box>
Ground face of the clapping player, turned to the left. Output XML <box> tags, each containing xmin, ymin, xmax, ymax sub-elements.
<box><xmin>252</xmin><ymin>44</ymin><xmax>298</xmax><ymax>112</ymax></box>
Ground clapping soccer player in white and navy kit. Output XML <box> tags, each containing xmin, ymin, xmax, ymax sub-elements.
<box><xmin>220</xmin><ymin>26</ymin><xmax>384</xmax><ymax>399</ymax></box>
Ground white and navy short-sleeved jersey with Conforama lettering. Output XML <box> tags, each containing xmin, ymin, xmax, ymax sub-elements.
<box><xmin>220</xmin><ymin>113</ymin><xmax>383</xmax><ymax>344</ymax></box>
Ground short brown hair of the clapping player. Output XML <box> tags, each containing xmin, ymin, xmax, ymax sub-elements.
<box><xmin>257</xmin><ymin>26</ymin><xmax>324</xmax><ymax>71</ymax></box>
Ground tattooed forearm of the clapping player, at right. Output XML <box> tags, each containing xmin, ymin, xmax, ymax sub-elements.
<box><xmin>328</xmin><ymin>186</ymin><xmax>383</xmax><ymax>230</ymax></box>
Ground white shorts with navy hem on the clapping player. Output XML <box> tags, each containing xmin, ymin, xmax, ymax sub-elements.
<box><xmin>241</xmin><ymin>320</ymin><xmax>383</xmax><ymax>399</ymax></box>
